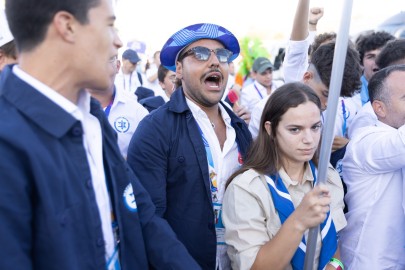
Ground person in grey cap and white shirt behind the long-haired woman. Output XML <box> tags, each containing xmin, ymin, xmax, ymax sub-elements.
<box><xmin>240</xmin><ymin>57</ymin><xmax>283</xmax><ymax>112</ymax></box>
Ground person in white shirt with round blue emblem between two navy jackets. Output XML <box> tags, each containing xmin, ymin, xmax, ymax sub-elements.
<box><xmin>87</xmin><ymin>57</ymin><xmax>149</xmax><ymax>159</ymax></box>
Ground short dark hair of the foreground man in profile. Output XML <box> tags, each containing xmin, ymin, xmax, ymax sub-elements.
<box><xmin>6</xmin><ymin>0</ymin><xmax>100</xmax><ymax>51</ymax></box>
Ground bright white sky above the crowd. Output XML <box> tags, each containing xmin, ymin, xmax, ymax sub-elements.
<box><xmin>116</xmin><ymin>0</ymin><xmax>405</xmax><ymax>58</ymax></box>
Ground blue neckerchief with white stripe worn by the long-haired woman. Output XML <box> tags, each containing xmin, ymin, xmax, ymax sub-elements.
<box><xmin>267</xmin><ymin>161</ymin><xmax>337</xmax><ymax>270</ymax></box>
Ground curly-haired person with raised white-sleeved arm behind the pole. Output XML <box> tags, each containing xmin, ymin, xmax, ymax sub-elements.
<box><xmin>249</xmin><ymin>0</ymin><xmax>361</xmax><ymax>139</ymax></box>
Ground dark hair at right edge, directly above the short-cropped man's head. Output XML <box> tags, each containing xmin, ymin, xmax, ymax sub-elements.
<box><xmin>375</xmin><ymin>39</ymin><xmax>405</xmax><ymax>68</ymax></box>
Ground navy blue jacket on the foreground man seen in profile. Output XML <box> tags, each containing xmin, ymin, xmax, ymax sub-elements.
<box><xmin>0</xmin><ymin>67</ymin><xmax>199</xmax><ymax>270</ymax></box>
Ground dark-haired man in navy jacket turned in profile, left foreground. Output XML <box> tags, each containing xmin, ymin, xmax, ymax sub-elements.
<box><xmin>0</xmin><ymin>0</ymin><xmax>199</xmax><ymax>270</ymax></box>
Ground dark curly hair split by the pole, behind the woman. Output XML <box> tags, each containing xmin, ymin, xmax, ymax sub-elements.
<box><xmin>311</xmin><ymin>42</ymin><xmax>362</xmax><ymax>97</ymax></box>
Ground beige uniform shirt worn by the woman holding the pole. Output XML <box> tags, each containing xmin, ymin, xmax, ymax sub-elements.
<box><xmin>222</xmin><ymin>162</ymin><xmax>346</xmax><ymax>269</ymax></box>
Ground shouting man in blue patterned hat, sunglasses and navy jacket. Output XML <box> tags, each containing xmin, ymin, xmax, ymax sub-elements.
<box><xmin>128</xmin><ymin>23</ymin><xmax>252</xmax><ymax>269</ymax></box>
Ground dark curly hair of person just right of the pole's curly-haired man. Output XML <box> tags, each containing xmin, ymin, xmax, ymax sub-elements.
<box><xmin>356</xmin><ymin>31</ymin><xmax>395</xmax><ymax>64</ymax></box>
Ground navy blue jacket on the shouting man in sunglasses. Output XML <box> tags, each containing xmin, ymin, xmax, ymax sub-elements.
<box><xmin>128</xmin><ymin>88</ymin><xmax>252</xmax><ymax>269</ymax></box>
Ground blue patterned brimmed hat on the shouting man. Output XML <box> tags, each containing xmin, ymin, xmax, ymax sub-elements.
<box><xmin>160</xmin><ymin>23</ymin><xmax>240</xmax><ymax>71</ymax></box>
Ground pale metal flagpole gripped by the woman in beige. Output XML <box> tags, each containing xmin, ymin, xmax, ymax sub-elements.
<box><xmin>304</xmin><ymin>0</ymin><xmax>353</xmax><ymax>270</ymax></box>
